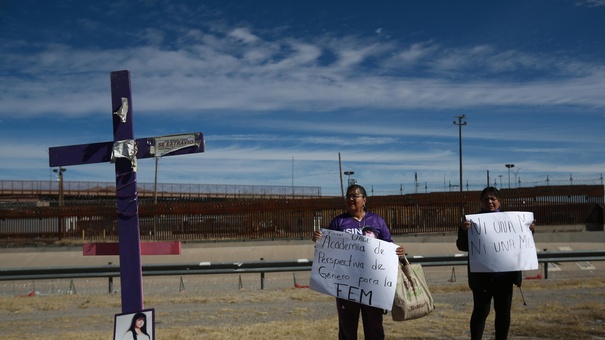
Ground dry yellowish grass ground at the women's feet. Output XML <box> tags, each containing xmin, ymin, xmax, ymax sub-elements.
<box><xmin>0</xmin><ymin>278</ymin><xmax>605</xmax><ymax>340</ymax></box>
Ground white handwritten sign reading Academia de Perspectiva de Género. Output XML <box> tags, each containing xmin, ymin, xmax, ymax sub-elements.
<box><xmin>309</xmin><ymin>229</ymin><xmax>398</xmax><ymax>310</ymax></box>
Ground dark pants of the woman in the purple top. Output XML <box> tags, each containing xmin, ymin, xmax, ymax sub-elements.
<box><xmin>336</xmin><ymin>299</ymin><xmax>384</xmax><ymax>340</ymax></box>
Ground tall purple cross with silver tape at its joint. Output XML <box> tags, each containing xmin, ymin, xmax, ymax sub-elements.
<box><xmin>48</xmin><ymin>70</ymin><xmax>204</xmax><ymax>313</ymax></box>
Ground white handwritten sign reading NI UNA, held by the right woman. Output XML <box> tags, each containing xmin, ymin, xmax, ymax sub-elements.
<box><xmin>466</xmin><ymin>211</ymin><xmax>538</xmax><ymax>273</ymax></box>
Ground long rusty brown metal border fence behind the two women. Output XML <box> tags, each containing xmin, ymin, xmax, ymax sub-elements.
<box><xmin>0</xmin><ymin>185</ymin><xmax>604</xmax><ymax>244</ymax></box>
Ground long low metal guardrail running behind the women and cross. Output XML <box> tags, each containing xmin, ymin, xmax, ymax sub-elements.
<box><xmin>0</xmin><ymin>250</ymin><xmax>605</xmax><ymax>292</ymax></box>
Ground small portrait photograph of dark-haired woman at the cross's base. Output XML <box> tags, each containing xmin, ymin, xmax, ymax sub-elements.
<box><xmin>113</xmin><ymin>309</ymin><xmax>155</xmax><ymax>340</ymax></box>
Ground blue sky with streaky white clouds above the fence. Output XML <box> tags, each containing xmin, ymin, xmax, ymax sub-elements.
<box><xmin>0</xmin><ymin>0</ymin><xmax>605</xmax><ymax>194</ymax></box>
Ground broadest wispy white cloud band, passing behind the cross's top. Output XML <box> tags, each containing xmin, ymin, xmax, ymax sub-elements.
<box><xmin>0</xmin><ymin>29</ymin><xmax>605</xmax><ymax>119</ymax></box>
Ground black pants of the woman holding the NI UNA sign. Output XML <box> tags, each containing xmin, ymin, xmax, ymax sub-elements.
<box><xmin>470</xmin><ymin>282</ymin><xmax>513</xmax><ymax>340</ymax></box>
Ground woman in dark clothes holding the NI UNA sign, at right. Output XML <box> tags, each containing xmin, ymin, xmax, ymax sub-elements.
<box><xmin>456</xmin><ymin>187</ymin><xmax>535</xmax><ymax>340</ymax></box>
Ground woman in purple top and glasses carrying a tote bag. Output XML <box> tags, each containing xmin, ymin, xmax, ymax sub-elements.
<box><xmin>313</xmin><ymin>184</ymin><xmax>405</xmax><ymax>340</ymax></box>
